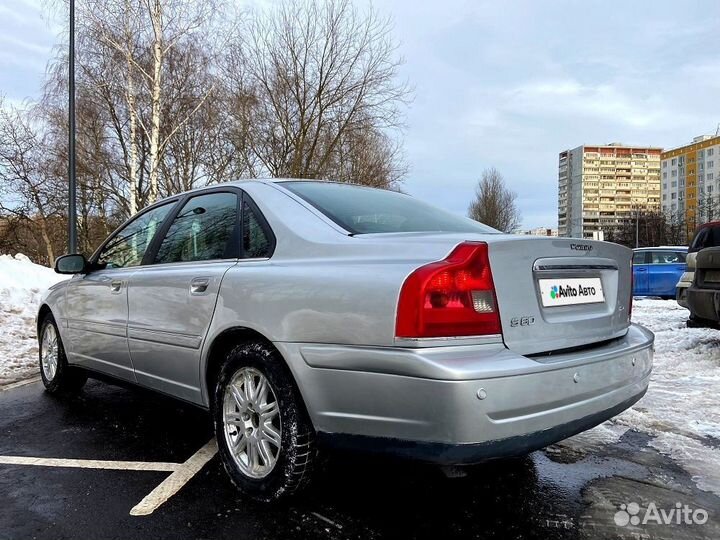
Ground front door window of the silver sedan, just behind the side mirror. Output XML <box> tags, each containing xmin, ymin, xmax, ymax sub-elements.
<box><xmin>97</xmin><ymin>203</ymin><xmax>175</xmax><ymax>268</ymax></box>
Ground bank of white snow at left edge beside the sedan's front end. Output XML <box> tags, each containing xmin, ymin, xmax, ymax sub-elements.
<box><xmin>0</xmin><ymin>254</ymin><xmax>65</xmax><ymax>385</ymax></box>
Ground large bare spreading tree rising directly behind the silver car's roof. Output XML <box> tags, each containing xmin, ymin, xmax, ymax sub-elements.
<box><xmin>229</xmin><ymin>0</ymin><xmax>409</xmax><ymax>186</ymax></box>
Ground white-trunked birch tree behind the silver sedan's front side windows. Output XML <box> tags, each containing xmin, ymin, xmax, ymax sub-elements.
<box><xmin>77</xmin><ymin>0</ymin><xmax>218</xmax><ymax>206</ymax></box>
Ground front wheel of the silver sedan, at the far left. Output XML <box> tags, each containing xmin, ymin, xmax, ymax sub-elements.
<box><xmin>38</xmin><ymin>314</ymin><xmax>87</xmax><ymax>394</ymax></box>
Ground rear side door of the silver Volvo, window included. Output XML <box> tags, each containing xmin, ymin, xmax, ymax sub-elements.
<box><xmin>128</xmin><ymin>188</ymin><xmax>241</xmax><ymax>403</ymax></box>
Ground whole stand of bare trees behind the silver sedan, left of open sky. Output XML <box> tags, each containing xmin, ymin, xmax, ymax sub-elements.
<box><xmin>0</xmin><ymin>0</ymin><xmax>410</xmax><ymax>263</ymax></box>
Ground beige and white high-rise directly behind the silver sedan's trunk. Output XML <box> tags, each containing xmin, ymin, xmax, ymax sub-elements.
<box><xmin>558</xmin><ymin>143</ymin><xmax>662</xmax><ymax>239</ymax></box>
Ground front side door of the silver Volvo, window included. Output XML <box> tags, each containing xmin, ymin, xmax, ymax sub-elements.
<box><xmin>66</xmin><ymin>201</ymin><xmax>177</xmax><ymax>381</ymax></box>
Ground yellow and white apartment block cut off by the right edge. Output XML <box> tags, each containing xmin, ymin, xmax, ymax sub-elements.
<box><xmin>660</xmin><ymin>135</ymin><xmax>720</xmax><ymax>237</ymax></box>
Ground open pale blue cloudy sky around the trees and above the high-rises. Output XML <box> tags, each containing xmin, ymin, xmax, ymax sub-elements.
<box><xmin>0</xmin><ymin>0</ymin><xmax>720</xmax><ymax>228</ymax></box>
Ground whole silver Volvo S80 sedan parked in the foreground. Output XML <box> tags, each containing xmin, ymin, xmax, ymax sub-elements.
<box><xmin>38</xmin><ymin>180</ymin><xmax>654</xmax><ymax>501</ymax></box>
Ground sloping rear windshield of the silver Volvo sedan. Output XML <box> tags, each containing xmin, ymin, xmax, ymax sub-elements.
<box><xmin>282</xmin><ymin>182</ymin><xmax>499</xmax><ymax>234</ymax></box>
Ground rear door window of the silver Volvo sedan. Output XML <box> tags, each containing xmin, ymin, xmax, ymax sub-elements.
<box><xmin>155</xmin><ymin>193</ymin><xmax>238</xmax><ymax>264</ymax></box>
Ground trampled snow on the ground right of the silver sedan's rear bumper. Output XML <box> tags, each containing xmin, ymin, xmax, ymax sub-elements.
<box><xmin>561</xmin><ymin>299</ymin><xmax>720</xmax><ymax>495</ymax></box>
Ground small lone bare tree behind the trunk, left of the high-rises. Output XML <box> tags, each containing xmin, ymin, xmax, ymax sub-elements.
<box><xmin>468</xmin><ymin>167</ymin><xmax>521</xmax><ymax>232</ymax></box>
